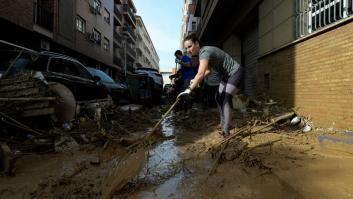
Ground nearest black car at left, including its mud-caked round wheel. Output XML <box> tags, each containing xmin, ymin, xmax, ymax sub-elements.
<box><xmin>0</xmin><ymin>40</ymin><xmax>110</xmax><ymax>122</ymax></box>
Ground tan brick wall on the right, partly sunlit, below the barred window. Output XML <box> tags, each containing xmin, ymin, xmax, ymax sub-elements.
<box><xmin>258</xmin><ymin>22</ymin><xmax>353</xmax><ymax>129</ymax></box>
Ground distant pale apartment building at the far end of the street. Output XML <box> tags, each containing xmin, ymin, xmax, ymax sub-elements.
<box><xmin>135</xmin><ymin>16</ymin><xmax>159</xmax><ymax>71</ymax></box>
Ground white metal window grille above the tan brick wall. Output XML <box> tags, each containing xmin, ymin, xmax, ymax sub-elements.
<box><xmin>296</xmin><ymin>0</ymin><xmax>353</xmax><ymax>38</ymax></box>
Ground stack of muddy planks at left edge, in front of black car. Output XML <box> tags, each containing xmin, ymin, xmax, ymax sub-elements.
<box><xmin>0</xmin><ymin>72</ymin><xmax>56</xmax><ymax>118</ymax></box>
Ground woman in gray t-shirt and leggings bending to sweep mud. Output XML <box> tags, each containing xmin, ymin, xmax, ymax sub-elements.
<box><xmin>178</xmin><ymin>34</ymin><xmax>242</xmax><ymax>138</ymax></box>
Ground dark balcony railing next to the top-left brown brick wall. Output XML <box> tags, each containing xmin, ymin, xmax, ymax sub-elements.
<box><xmin>34</xmin><ymin>3</ymin><xmax>54</xmax><ymax>31</ymax></box>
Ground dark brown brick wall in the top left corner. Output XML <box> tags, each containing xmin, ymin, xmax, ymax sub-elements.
<box><xmin>0</xmin><ymin>0</ymin><xmax>33</xmax><ymax>30</ymax></box>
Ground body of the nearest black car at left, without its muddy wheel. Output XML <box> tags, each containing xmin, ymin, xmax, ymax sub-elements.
<box><xmin>0</xmin><ymin>45</ymin><xmax>108</xmax><ymax>101</ymax></box>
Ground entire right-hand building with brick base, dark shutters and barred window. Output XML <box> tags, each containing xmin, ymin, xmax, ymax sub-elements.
<box><xmin>192</xmin><ymin>0</ymin><xmax>353</xmax><ymax>129</ymax></box>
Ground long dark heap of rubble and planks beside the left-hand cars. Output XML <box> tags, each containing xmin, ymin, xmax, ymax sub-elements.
<box><xmin>0</xmin><ymin>73</ymin><xmax>160</xmax><ymax>175</ymax></box>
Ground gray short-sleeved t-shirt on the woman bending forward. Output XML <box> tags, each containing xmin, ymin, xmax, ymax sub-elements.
<box><xmin>199</xmin><ymin>46</ymin><xmax>240</xmax><ymax>77</ymax></box>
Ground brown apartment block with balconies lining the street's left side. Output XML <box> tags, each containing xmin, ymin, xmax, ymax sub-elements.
<box><xmin>0</xmin><ymin>0</ymin><xmax>140</xmax><ymax>79</ymax></box>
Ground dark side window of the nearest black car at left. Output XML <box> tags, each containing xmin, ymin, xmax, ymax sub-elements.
<box><xmin>49</xmin><ymin>58</ymin><xmax>92</xmax><ymax>79</ymax></box>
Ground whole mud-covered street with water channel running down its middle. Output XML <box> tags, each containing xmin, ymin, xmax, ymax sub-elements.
<box><xmin>0</xmin><ymin>102</ymin><xmax>353</xmax><ymax>198</ymax></box>
